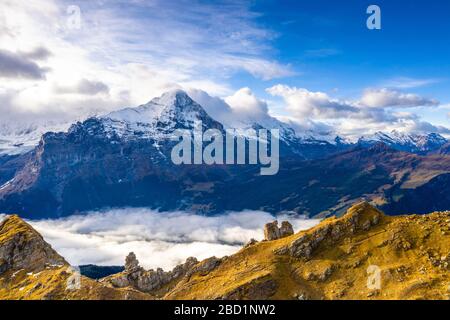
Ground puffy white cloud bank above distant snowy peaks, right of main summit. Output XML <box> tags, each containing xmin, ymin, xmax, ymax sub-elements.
<box><xmin>267</xmin><ymin>85</ymin><xmax>449</xmax><ymax>139</ymax></box>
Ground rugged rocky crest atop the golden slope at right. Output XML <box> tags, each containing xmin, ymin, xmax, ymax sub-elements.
<box><xmin>276</xmin><ymin>202</ymin><xmax>382</xmax><ymax>260</ymax></box>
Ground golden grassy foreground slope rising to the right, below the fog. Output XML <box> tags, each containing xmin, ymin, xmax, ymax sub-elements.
<box><xmin>165</xmin><ymin>203</ymin><xmax>450</xmax><ymax>299</ymax></box>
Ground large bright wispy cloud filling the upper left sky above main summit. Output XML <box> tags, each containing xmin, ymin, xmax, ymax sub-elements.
<box><xmin>0</xmin><ymin>0</ymin><xmax>293</xmax><ymax>132</ymax></box>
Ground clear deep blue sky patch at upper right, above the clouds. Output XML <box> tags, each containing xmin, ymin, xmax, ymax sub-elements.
<box><xmin>250</xmin><ymin>0</ymin><xmax>450</xmax><ymax>95</ymax></box>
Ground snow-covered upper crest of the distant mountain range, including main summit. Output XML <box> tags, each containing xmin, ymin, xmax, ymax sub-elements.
<box><xmin>0</xmin><ymin>90</ymin><xmax>449</xmax><ymax>155</ymax></box>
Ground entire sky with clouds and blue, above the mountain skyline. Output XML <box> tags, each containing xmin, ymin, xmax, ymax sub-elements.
<box><xmin>0</xmin><ymin>0</ymin><xmax>450</xmax><ymax>135</ymax></box>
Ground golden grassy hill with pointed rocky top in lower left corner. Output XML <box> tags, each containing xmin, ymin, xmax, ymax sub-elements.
<box><xmin>0</xmin><ymin>215</ymin><xmax>152</xmax><ymax>300</ymax></box>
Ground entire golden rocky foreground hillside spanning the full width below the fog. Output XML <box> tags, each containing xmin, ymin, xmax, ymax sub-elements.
<box><xmin>0</xmin><ymin>203</ymin><xmax>450</xmax><ymax>300</ymax></box>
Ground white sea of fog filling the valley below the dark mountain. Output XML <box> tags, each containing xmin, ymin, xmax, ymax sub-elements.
<box><xmin>0</xmin><ymin>208</ymin><xmax>319</xmax><ymax>270</ymax></box>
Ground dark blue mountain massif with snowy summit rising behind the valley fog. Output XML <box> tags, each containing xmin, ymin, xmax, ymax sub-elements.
<box><xmin>0</xmin><ymin>91</ymin><xmax>450</xmax><ymax>218</ymax></box>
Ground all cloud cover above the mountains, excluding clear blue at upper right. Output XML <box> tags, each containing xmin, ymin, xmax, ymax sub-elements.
<box><xmin>0</xmin><ymin>0</ymin><xmax>448</xmax><ymax>140</ymax></box>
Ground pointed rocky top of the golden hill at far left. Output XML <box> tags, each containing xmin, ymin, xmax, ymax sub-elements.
<box><xmin>0</xmin><ymin>215</ymin><xmax>68</xmax><ymax>274</ymax></box>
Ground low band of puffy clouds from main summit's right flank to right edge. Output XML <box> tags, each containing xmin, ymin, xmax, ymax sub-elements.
<box><xmin>189</xmin><ymin>85</ymin><xmax>449</xmax><ymax>140</ymax></box>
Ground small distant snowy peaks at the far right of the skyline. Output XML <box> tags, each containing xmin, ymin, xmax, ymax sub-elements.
<box><xmin>358</xmin><ymin>130</ymin><xmax>448</xmax><ymax>153</ymax></box>
